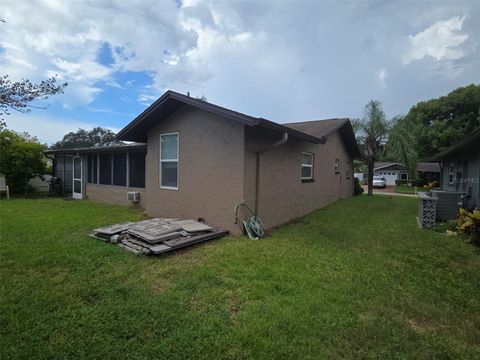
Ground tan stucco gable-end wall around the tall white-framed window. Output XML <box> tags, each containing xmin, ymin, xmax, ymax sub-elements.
<box><xmin>146</xmin><ymin>106</ymin><xmax>245</xmax><ymax>234</ymax></box>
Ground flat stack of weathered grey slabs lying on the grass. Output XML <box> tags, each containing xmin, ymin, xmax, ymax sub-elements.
<box><xmin>92</xmin><ymin>219</ymin><xmax>228</xmax><ymax>254</ymax></box>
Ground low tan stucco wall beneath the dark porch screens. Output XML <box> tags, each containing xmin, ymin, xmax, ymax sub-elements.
<box><xmin>86</xmin><ymin>184</ymin><xmax>147</xmax><ymax>209</ymax></box>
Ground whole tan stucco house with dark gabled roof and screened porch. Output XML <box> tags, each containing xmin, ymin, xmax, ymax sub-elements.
<box><xmin>46</xmin><ymin>91</ymin><xmax>360</xmax><ymax>233</ymax></box>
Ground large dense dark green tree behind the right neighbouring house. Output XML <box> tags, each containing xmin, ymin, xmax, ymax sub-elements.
<box><xmin>400</xmin><ymin>84</ymin><xmax>480</xmax><ymax>160</ymax></box>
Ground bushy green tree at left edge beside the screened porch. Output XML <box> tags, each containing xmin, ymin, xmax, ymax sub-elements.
<box><xmin>0</xmin><ymin>129</ymin><xmax>47</xmax><ymax>195</ymax></box>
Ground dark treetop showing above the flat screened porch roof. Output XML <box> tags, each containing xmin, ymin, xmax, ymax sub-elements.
<box><xmin>52</xmin><ymin>127</ymin><xmax>123</xmax><ymax>149</ymax></box>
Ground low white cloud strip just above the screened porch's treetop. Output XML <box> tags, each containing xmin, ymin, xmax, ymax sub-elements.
<box><xmin>7</xmin><ymin>113</ymin><xmax>120</xmax><ymax>145</ymax></box>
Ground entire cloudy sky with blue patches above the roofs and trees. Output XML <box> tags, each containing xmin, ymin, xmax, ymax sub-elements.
<box><xmin>0</xmin><ymin>0</ymin><xmax>480</xmax><ymax>143</ymax></box>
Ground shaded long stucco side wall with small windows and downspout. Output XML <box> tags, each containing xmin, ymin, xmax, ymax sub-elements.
<box><xmin>244</xmin><ymin>129</ymin><xmax>354</xmax><ymax>228</ymax></box>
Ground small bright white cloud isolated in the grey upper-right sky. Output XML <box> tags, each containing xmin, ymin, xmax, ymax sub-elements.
<box><xmin>402</xmin><ymin>16</ymin><xmax>468</xmax><ymax>65</ymax></box>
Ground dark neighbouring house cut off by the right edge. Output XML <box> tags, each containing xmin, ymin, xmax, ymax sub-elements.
<box><xmin>432</xmin><ymin>127</ymin><xmax>480</xmax><ymax>209</ymax></box>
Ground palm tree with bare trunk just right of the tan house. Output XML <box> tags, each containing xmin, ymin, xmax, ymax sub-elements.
<box><xmin>353</xmin><ymin>100</ymin><xmax>389</xmax><ymax>195</ymax></box>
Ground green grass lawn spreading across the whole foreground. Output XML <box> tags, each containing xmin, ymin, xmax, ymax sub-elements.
<box><xmin>0</xmin><ymin>196</ymin><xmax>480</xmax><ymax>359</ymax></box>
